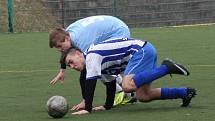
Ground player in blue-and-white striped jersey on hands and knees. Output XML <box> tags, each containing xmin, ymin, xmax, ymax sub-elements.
<box><xmin>62</xmin><ymin>38</ymin><xmax>196</xmax><ymax>115</ymax></box>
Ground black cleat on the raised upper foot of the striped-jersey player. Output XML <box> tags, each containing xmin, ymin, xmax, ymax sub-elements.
<box><xmin>162</xmin><ymin>58</ymin><xmax>190</xmax><ymax>76</ymax></box>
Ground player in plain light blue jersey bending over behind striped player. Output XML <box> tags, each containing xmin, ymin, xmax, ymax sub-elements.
<box><xmin>49</xmin><ymin>15</ymin><xmax>134</xmax><ymax>110</ymax></box>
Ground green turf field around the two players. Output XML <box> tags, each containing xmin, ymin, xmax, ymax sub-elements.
<box><xmin>0</xmin><ymin>25</ymin><xmax>215</xmax><ymax>121</ymax></box>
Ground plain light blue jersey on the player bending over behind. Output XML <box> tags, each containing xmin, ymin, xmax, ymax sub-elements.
<box><xmin>66</xmin><ymin>15</ymin><xmax>130</xmax><ymax>52</ymax></box>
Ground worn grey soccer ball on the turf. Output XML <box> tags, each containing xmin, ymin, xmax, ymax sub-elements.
<box><xmin>46</xmin><ymin>96</ymin><xmax>69</xmax><ymax>118</ymax></box>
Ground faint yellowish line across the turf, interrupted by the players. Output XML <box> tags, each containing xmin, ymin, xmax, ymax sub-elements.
<box><xmin>0</xmin><ymin>64</ymin><xmax>215</xmax><ymax>73</ymax></box>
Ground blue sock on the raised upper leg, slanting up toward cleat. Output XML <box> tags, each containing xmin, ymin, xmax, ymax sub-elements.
<box><xmin>133</xmin><ymin>65</ymin><xmax>168</xmax><ymax>88</ymax></box>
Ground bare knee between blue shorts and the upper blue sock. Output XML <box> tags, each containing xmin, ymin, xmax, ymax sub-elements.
<box><xmin>122</xmin><ymin>75</ymin><xmax>137</xmax><ymax>93</ymax></box>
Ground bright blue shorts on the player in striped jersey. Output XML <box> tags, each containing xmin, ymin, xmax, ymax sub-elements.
<box><xmin>124</xmin><ymin>42</ymin><xmax>157</xmax><ymax>75</ymax></box>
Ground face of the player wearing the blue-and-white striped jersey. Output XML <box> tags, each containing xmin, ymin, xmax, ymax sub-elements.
<box><xmin>66</xmin><ymin>51</ymin><xmax>85</xmax><ymax>71</ymax></box>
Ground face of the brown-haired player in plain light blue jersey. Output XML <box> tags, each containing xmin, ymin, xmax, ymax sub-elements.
<box><xmin>56</xmin><ymin>37</ymin><xmax>71</xmax><ymax>52</ymax></box>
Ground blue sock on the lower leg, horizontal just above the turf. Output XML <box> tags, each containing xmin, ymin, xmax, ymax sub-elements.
<box><xmin>160</xmin><ymin>88</ymin><xmax>187</xmax><ymax>99</ymax></box>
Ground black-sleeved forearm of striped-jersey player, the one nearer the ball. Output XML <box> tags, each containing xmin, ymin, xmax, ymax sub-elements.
<box><xmin>85</xmin><ymin>80</ymin><xmax>97</xmax><ymax>112</ymax></box>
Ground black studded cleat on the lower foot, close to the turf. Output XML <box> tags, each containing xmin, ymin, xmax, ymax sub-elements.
<box><xmin>181</xmin><ymin>88</ymin><xmax>196</xmax><ymax>107</ymax></box>
